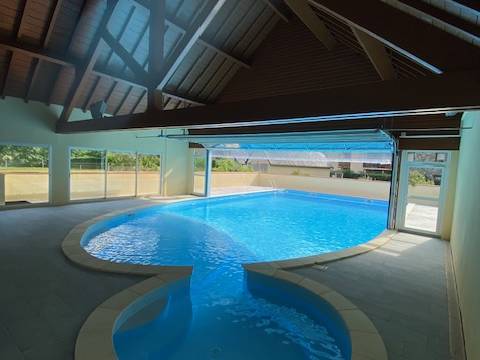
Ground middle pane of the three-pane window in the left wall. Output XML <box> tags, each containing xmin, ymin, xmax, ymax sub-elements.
<box><xmin>107</xmin><ymin>151</ymin><xmax>137</xmax><ymax>198</ymax></box>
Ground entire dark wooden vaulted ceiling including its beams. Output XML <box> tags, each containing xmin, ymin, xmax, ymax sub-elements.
<box><xmin>0</xmin><ymin>0</ymin><xmax>480</xmax><ymax>131</ymax></box>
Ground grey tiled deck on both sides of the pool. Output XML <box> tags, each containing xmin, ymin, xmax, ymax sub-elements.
<box><xmin>0</xmin><ymin>200</ymin><xmax>460</xmax><ymax>360</ymax></box>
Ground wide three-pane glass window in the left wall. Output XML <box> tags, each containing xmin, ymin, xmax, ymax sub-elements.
<box><xmin>70</xmin><ymin>149</ymin><xmax>161</xmax><ymax>200</ymax></box>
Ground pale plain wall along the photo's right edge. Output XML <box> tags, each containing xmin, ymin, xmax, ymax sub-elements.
<box><xmin>450</xmin><ymin>112</ymin><xmax>480</xmax><ymax>360</ymax></box>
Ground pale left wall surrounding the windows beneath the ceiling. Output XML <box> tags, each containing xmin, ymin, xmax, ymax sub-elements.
<box><xmin>0</xmin><ymin>97</ymin><xmax>189</xmax><ymax>204</ymax></box>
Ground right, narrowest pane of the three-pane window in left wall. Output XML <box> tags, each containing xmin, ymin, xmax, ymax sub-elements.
<box><xmin>137</xmin><ymin>154</ymin><xmax>161</xmax><ymax>195</ymax></box>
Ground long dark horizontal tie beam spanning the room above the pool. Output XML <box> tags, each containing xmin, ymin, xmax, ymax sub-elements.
<box><xmin>58</xmin><ymin>71</ymin><xmax>480</xmax><ymax>132</ymax></box>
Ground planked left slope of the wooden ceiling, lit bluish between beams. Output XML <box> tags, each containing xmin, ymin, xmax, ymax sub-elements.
<box><xmin>0</xmin><ymin>0</ymin><xmax>283</xmax><ymax>115</ymax></box>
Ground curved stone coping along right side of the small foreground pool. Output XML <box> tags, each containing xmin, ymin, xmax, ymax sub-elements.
<box><xmin>244</xmin><ymin>264</ymin><xmax>388</xmax><ymax>360</ymax></box>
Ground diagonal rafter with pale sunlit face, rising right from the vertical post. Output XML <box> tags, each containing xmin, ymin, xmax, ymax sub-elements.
<box><xmin>157</xmin><ymin>0</ymin><xmax>226</xmax><ymax>89</ymax></box>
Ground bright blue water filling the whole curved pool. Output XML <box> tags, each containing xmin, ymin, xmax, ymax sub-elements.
<box><xmin>82</xmin><ymin>191</ymin><xmax>387</xmax><ymax>360</ymax></box>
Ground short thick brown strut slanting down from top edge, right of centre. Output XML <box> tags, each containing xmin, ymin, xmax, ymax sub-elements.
<box><xmin>285</xmin><ymin>0</ymin><xmax>337</xmax><ymax>50</ymax></box>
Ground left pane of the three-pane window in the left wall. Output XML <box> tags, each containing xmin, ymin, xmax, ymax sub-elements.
<box><xmin>70</xmin><ymin>149</ymin><xmax>106</xmax><ymax>200</ymax></box>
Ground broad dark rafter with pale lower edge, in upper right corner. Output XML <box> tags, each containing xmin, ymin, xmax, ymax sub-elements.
<box><xmin>308</xmin><ymin>0</ymin><xmax>480</xmax><ymax>74</ymax></box>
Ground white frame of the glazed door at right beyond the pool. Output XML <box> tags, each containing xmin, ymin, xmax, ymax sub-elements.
<box><xmin>396</xmin><ymin>150</ymin><xmax>452</xmax><ymax>237</ymax></box>
